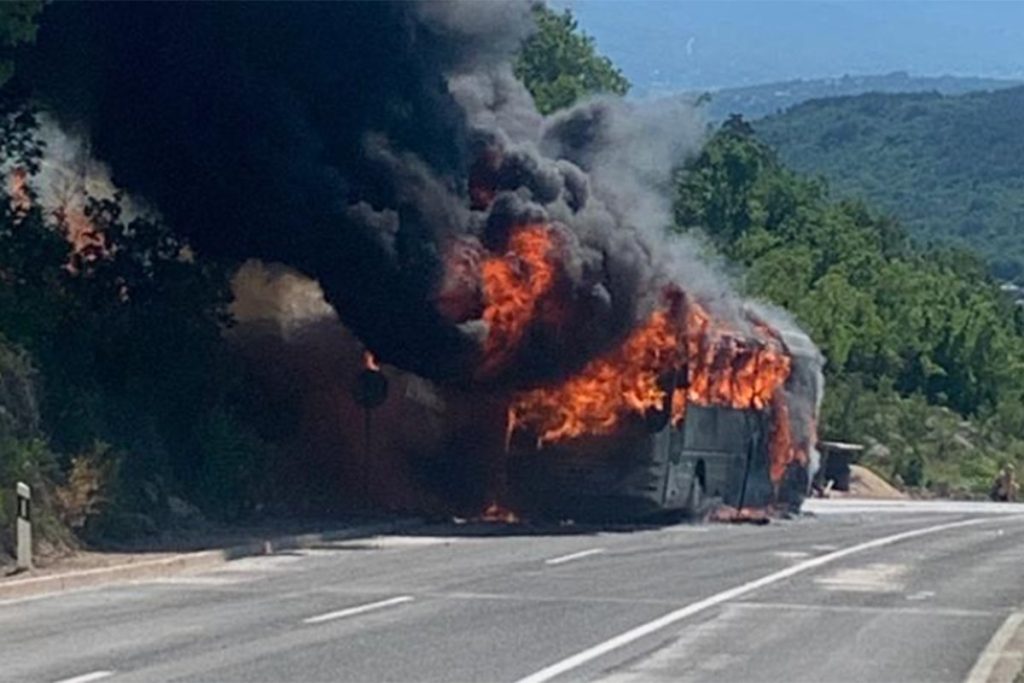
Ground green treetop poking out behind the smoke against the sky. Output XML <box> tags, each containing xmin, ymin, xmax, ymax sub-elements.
<box><xmin>515</xmin><ymin>4</ymin><xmax>630</xmax><ymax>114</ymax></box>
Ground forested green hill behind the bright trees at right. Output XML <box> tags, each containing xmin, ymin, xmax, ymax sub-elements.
<box><xmin>754</xmin><ymin>87</ymin><xmax>1024</xmax><ymax>283</ymax></box>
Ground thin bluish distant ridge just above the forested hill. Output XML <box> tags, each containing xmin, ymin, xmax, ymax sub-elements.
<box><xmin>688</xmin><ymin>72</ymin><xmax>1022</xmax><ymax>121</ymax></box>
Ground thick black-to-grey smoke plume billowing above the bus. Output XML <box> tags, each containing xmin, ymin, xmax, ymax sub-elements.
<box><xmin>22</xmin><ymin>2</ymin><xmax>718</xmax><ymax>383</ymax></box>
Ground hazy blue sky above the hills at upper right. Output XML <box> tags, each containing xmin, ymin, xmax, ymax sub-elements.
<box><xmin>552</xmin><ymin>0</ymin><xmax>1024</xmax><ymax>94</ymax></box>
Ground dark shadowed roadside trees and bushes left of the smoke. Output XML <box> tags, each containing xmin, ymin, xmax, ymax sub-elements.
<box><xmin>0</xmin><ymin>92</ymin><xmax>272</xmax><ymax>554</ymax></box>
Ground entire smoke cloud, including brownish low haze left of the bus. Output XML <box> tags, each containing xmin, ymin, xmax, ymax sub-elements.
<box><xmin>9</xmin><ymin>0</ymin><xmax>821</xmax><ymax>510</ymax></box>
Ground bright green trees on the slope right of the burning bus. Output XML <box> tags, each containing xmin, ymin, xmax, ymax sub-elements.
<box><xmin>676</xmin><ymin>118</ymin><xmax>1024</xmax><ymax>491</ymax></box>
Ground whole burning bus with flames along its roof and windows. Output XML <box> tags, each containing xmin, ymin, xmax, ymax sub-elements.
<box><xmin>497</xmin><ymin>286</ymin><xmax>822</xmax><ymax>520</ymax></box>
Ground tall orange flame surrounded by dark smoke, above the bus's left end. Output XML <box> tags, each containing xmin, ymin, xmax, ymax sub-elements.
<box><xmin>480</xmin><ymin>223</ymin><xmax>556</xmax><ymax>375</ymax></box>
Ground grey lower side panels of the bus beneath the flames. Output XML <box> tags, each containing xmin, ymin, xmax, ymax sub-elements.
<box><xmin>509</xmin><ymin>405</ymin><xmax>771</xmax><ymax>520</ymax></box>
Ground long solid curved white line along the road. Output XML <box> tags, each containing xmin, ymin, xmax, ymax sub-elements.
<box><xmin>518</xmin><ymin>517</ymin><xmax>1024</xmax><ymax>683</ymax></box>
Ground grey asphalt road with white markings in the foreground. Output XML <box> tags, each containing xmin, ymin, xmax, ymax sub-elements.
<box><xmin>0</xmin><ymin>501</ymin><xmax>1024</xmax><ymax>683</ymax></box>
